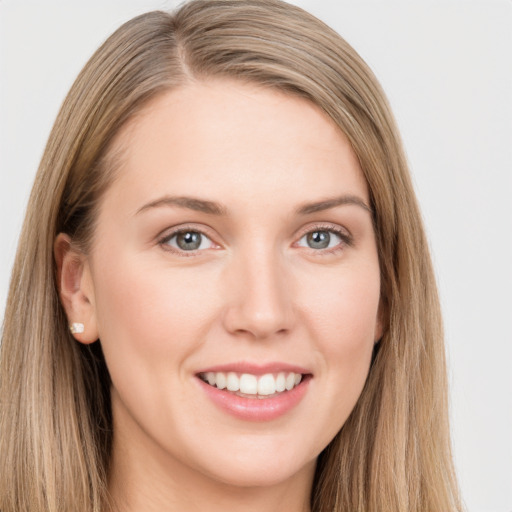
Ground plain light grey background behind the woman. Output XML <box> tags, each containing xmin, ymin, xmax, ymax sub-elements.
<box><xmin>0</xmin><ymin>0</ymin><xmax>512</xmax><ymax>512</ymax></box>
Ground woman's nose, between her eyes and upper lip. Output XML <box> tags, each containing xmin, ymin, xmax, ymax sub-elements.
<box><xmin>224</xmin><ymin>247</ymin><xmax>296</xmax><ymax>340</ymax></box>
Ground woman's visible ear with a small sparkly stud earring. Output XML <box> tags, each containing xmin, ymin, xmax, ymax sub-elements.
<box><xmin>53</xmin><ymin>233</ymin><xmax>98</xmax><ymax>344</ymax></box>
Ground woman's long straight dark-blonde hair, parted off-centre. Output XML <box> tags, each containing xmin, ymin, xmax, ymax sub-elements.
<box><xmin>0</xmin><ymin>0</ymin><xmax>461</xmax><ymax>512</ymax></box>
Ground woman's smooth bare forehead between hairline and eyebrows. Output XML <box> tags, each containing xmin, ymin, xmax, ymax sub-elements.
<box><xmin>104</xmin><ymin>81</ymin><xmax>368</xmax><ymax>214</ymax></box>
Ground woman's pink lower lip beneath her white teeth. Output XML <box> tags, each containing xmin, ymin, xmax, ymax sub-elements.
<box><xmin>197</xmin><ymin>376</ymin><xmax>311</xmax><ymax>421</ymax></box>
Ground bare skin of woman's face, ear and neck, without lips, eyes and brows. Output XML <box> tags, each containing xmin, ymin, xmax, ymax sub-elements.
<box><xmin>55</xmin><ymin>81</ymin><xmax>381</xmax><ymax>512</ymax></box>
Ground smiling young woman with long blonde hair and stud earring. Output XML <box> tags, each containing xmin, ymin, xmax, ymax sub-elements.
<box><xmin>0</xmin><ymin>0</ymin><xmax>460</xmax><ymax>512</ymax></box>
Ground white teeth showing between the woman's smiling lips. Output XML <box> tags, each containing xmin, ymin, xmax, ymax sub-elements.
<box><xmin>198</xmin><ymin>372</ymin><xmax>308</xmax><ymax>399</ymax></box>
